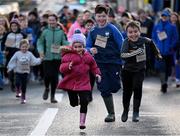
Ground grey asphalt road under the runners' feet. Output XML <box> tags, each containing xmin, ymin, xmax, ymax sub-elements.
<box><xmin>0</xmin><ymin>78</ymin><xmax>180</xmax><ymax>136</ymax></box>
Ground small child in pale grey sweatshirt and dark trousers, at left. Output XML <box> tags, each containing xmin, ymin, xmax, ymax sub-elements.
<box><xmin>7</xmin><ymin>39</ymin><xmax>42</xmax><ymax>104</ymax></box>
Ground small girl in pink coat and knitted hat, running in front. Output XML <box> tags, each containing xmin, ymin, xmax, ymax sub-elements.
<box><xmin>58</xmin><ymin>33</ymin><xmax>101</xmax><ymax>129</ymax></box>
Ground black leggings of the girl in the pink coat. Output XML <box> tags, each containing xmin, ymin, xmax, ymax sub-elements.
<box><xmin>67</xmin><ymin>90</ymin><xmax>90</xmax><ymax>113</ymax></box>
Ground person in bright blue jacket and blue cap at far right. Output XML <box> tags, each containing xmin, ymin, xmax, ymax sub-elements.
<box><xmin>152</xmin><ymin>10</ymin><xmax>178</xmax><ymax>93</ymax></box>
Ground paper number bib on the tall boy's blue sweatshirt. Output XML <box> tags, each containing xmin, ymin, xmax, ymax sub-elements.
<box><xmin>95</xmin><ymin>35</ymin><xmax>107</xmax><ymax>48</ymax></box>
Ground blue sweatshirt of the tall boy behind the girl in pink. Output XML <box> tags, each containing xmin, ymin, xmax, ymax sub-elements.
<box><xmin>86</xmin><ymin>24</ymin><xmax>124</xmax><ymax>64</ymax></box>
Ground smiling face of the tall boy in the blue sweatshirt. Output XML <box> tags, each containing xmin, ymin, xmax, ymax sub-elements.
<box><xmin>95</xmin><ymin>12</ymin><xmax>108</xmax><ymax>27</ymax></box>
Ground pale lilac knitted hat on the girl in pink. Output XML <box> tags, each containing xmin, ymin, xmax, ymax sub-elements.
<box><xmin>72</xmin><ymin>31</ymin><xmax>86</xmax><ymax>46</ymax></box>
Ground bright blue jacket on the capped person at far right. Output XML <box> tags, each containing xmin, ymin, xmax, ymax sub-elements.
<box><xmin>152</xmin><ymin>20</ymin><xmax>178</xmax><ymax>56</ymax></box>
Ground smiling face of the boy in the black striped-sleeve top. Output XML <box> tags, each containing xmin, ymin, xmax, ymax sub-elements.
<box><xmin>127</xmin><ymin>26</ymin><xmax>141</xmax><ymax>42</ymax></box>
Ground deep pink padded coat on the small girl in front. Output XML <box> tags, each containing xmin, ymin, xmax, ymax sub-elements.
<box><xmin>58</xmin><ymin>47</ymin><xmax>101</xmax><ymax>91</ymax></box>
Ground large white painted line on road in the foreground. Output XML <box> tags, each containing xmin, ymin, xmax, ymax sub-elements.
<box><xmin>30</xmin><ymin>108</ymin><xmax>58</xmax><ymax>136</ymax></box>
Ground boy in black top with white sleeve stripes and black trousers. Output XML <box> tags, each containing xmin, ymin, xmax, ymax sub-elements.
<box><xmin>121</xmin><ymin>21</ymin><xmax>162</xmax><ymax>122</ymax></box>
